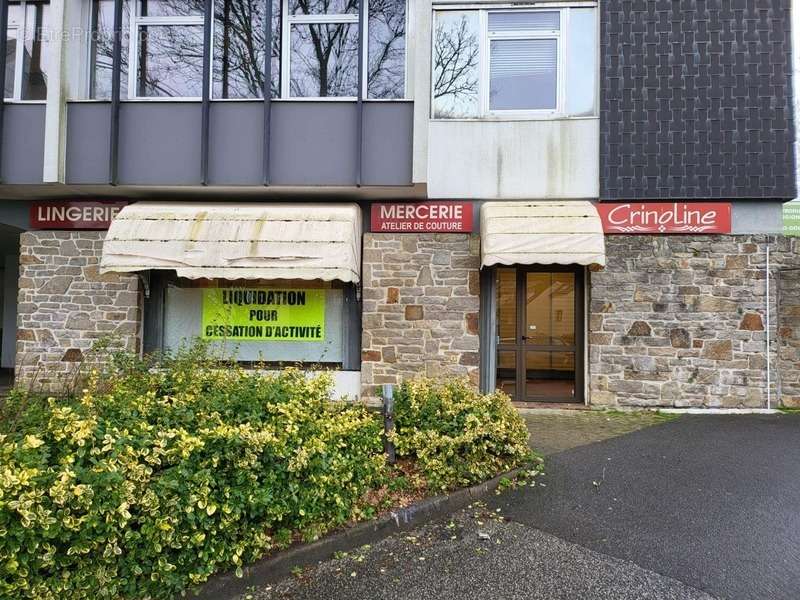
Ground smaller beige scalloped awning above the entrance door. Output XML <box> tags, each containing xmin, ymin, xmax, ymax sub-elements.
<box><xmin>481</xmin><ymin>201</ymin><xmax>606</xmax><ymax>267</ymax></box>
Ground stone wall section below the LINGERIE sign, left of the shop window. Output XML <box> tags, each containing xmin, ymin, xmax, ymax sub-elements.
<box><xmin>16</xmin><ymin>231</ymin><xmax>141</xmax><ymax>391</ymax></box>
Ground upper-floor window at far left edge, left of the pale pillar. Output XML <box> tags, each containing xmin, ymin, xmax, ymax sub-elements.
<box><xmin>4</xmin><ymin>1</ymin><xmax>50</xmax><ymax>100</ymax></box>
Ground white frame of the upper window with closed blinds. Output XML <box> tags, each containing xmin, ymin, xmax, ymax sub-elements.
<box><xmin>429</xmin><ymin>1</ymin><xmax>599</xmax><ymax>121</ymax></box>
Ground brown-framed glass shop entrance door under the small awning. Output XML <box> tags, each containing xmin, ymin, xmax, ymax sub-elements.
<box><xmin>497</xmin><ymin>266</ymin><xmax>584</xmax><ymax>403</ymax></box>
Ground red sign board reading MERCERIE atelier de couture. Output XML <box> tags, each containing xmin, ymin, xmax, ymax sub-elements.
<box><xmin>370</xmin><ymin>201</ymin><xmax>473</xmax><ymax>233</ymax></box>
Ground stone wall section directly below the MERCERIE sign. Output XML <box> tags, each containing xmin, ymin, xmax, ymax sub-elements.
<box><xmin>361</xmin><ymin>233</ymin><xmax>480</xmax><ymax>400</ymax></box>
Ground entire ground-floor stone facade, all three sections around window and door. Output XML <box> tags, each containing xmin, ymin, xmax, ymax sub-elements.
<box><xmin>16</xmin><ymin>231</ymin><xmax>800</xmax><ymax>408</ymax></box>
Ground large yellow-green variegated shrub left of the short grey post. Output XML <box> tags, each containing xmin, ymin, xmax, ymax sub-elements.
<box><xmin>0</xmin><ymin>349</ymin><xmax>386</xmax><ymax>600</ymax></box>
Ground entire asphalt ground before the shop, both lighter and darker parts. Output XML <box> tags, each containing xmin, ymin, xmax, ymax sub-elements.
<box><xmin>242</xmin><ymin>415</ymin><xmax>800</xmax><ymax>600</ymax></box>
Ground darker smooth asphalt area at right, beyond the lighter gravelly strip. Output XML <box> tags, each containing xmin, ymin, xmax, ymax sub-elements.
<box><xmin>494</xmin><ymin>414</ymin><xmax>800</xmax><ymax>600</ymax></box>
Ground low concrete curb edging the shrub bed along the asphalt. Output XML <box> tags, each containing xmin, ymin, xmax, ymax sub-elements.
<box><xmin>189</xmin><ymin>467</ymin><xmax>526</xmax><ymax>600</ymax></box>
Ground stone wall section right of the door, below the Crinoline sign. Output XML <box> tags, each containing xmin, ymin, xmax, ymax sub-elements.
<box><xmin>588</xmin><ymin>235</ymin><xmax>800</xmax><ymax>407</ymax></box>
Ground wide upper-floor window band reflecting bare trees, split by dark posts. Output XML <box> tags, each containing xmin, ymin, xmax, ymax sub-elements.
<box><xmin>91</xmin><ymin>0</ymin><xmax>406</xmax><ymax>99</ymax></box>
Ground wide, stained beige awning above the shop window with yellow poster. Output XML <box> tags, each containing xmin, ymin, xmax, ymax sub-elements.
<box><xmin>100</xmin><ymin>202</ymin><xmax>361</xmax><ymax>283</ymax></box>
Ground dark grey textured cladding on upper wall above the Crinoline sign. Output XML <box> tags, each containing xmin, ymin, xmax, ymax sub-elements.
<box><xmin>600</xmin><ymin>0</ymin><xmax>795</xmax><ymax>200</ymax></box>
